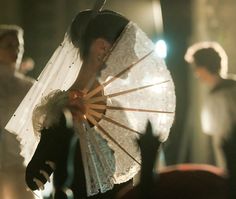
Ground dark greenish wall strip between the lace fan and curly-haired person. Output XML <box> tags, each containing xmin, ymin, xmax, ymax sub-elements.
<box><xmin>161</xmin><ymin>0</ymin><xmax>192</xmax><ymax>164</ymax></box>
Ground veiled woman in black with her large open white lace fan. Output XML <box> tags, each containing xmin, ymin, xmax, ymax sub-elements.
<box><xmin>6</xmin><ymin>0</ymin><xmax>175</xmax><ymax>198</ymax></box>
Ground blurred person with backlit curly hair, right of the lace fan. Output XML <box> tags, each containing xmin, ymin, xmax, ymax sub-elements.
<box><xmin>185</xmin><ymin>42</ymin><xmax>236</xmax><ymax>169</ymax></box>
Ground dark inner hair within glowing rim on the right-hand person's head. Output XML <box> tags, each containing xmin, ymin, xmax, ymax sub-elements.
<box><xmin>193</xmin><ymin>48</ymin><xmax>221</xmax><ymax>74</ymax></box>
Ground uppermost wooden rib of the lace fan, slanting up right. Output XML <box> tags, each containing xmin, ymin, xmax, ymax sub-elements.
<box><xmin>85</xmin><ymin>50</ymin><xmax>154</xmax><ymax>99</ymax></box>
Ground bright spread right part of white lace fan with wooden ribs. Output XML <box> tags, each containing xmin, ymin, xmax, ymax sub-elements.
<box><xmin>81</xmin><ymin>22</ymin><xmax>175</xmax><ymax>182</ymax></box>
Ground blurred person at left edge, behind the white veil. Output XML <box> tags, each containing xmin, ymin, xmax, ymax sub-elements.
<box><xmin>0</xmin><ymin>25</ymin><xmax>34</xmax><ymax>199</ymax></box>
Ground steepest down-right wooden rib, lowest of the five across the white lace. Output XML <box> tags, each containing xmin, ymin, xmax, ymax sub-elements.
<box><xmin>87</xmin><ymin>115</ymin><xmax>141</xmax><ymax>165</ymax></box>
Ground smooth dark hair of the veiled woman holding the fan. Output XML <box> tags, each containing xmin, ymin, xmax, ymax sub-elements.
<box><xmin>69</xmin><ymin>10</ymin><xmax>129</xmax><ymax>59</ymax></box>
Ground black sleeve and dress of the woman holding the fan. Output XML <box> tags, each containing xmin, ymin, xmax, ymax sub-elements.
<box><xmin>26</xmin><ymin>112</ymin><xmax>132</xmax><ymax>199</ymax></box>
